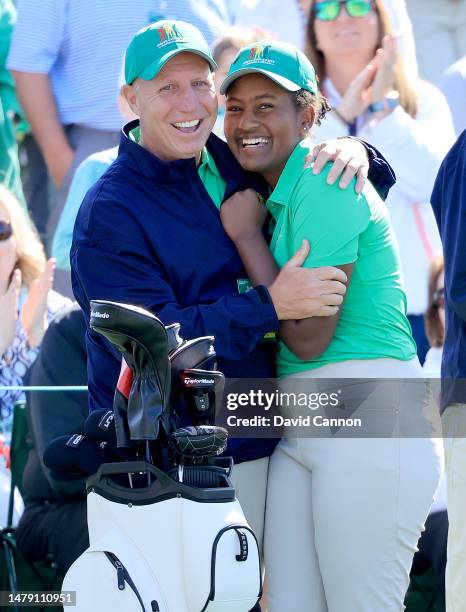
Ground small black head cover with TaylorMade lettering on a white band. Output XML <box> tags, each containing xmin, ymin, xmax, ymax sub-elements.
<box><xmin>179</xmin><ymin>369</ymin><xmax>225</xmax><ymax>425</ymax></box>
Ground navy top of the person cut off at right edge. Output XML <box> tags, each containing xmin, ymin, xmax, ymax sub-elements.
<box><xmin>431</xmin><ymin>131</ymin><xmax>466</xmax><ymax>408</ymax></box>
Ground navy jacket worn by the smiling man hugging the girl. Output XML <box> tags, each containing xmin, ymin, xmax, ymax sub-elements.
<box><xmin>71</xmin><ymin>122</ymin><xmax>393</xmax><ymax>463</ymax></box>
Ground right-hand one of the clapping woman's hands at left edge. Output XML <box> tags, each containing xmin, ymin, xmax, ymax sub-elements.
<box><xmin>21</xmin><ymin>259</ymin><xmax>55</xmax><ymax>347</ymax></box>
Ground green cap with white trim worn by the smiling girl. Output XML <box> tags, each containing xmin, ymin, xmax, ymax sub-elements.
<box><xmin>220</xmin><ymin>40</ymin><xmax>318</xmax><ymax>94</ymax></box>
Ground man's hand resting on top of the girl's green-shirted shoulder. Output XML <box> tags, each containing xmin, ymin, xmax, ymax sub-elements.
<box><xmin>306</xmin><ymin>138</ymin><xmax>369</xmax><ymax>193</ymax></box>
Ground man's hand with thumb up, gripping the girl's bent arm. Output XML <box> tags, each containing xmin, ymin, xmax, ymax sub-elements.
<box><xmin>268</xmin><ymin>240</ymin><xmax>347</xmax><ymax>320</ymax></box>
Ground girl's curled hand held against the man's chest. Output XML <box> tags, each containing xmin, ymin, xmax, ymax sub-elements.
<box><xmin>220</xmin><ymin>189</ymin><xmax>267</xmax><ymax>243</ymax></box>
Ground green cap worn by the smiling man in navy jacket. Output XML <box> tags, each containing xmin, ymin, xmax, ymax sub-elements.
<box><xmin>125</xmin><ymin>19</ymin><xmax>217</xmax><ymax>85</ymax></box>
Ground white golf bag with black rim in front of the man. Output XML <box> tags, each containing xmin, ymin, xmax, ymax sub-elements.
<box><xmin>63</xmin><ymin>462</ymin><xmax>261</xmax><ymax>612</ymax></box>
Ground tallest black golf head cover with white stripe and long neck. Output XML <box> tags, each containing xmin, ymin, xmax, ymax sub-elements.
<box><xmin>90</xmin><ymin>300</ymin><xmax>171</xmax><ymax>440</ymax></box>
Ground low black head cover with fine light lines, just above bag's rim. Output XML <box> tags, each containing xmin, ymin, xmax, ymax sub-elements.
<box><xmin>170</xmin><ymin>425</ymin><xmax>228</xmax><ymax>459</ymax></box>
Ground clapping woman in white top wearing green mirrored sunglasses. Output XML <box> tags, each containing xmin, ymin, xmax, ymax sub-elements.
<box><xmin>306</xmin><ymin>0</ymin><xmax>455</xmax><ymax>363</ymax></box>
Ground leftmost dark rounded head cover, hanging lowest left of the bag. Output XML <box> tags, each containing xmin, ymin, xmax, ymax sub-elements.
<box><xmin>44</xmin><ymin>434</ymin><xmax>120</xmax><ymax>480</ymax></box>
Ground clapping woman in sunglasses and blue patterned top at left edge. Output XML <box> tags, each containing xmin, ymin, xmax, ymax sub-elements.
<box><xmin>0</xmin><ymin>186</ymin><xmax>69</xmax><ymax>452</ymax></box>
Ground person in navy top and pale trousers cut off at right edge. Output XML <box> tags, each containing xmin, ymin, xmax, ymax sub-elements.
<box><xmin>431</xmin><ymin>131</ymin><xmax>466</xmax><ymax>612</ymax></box>
